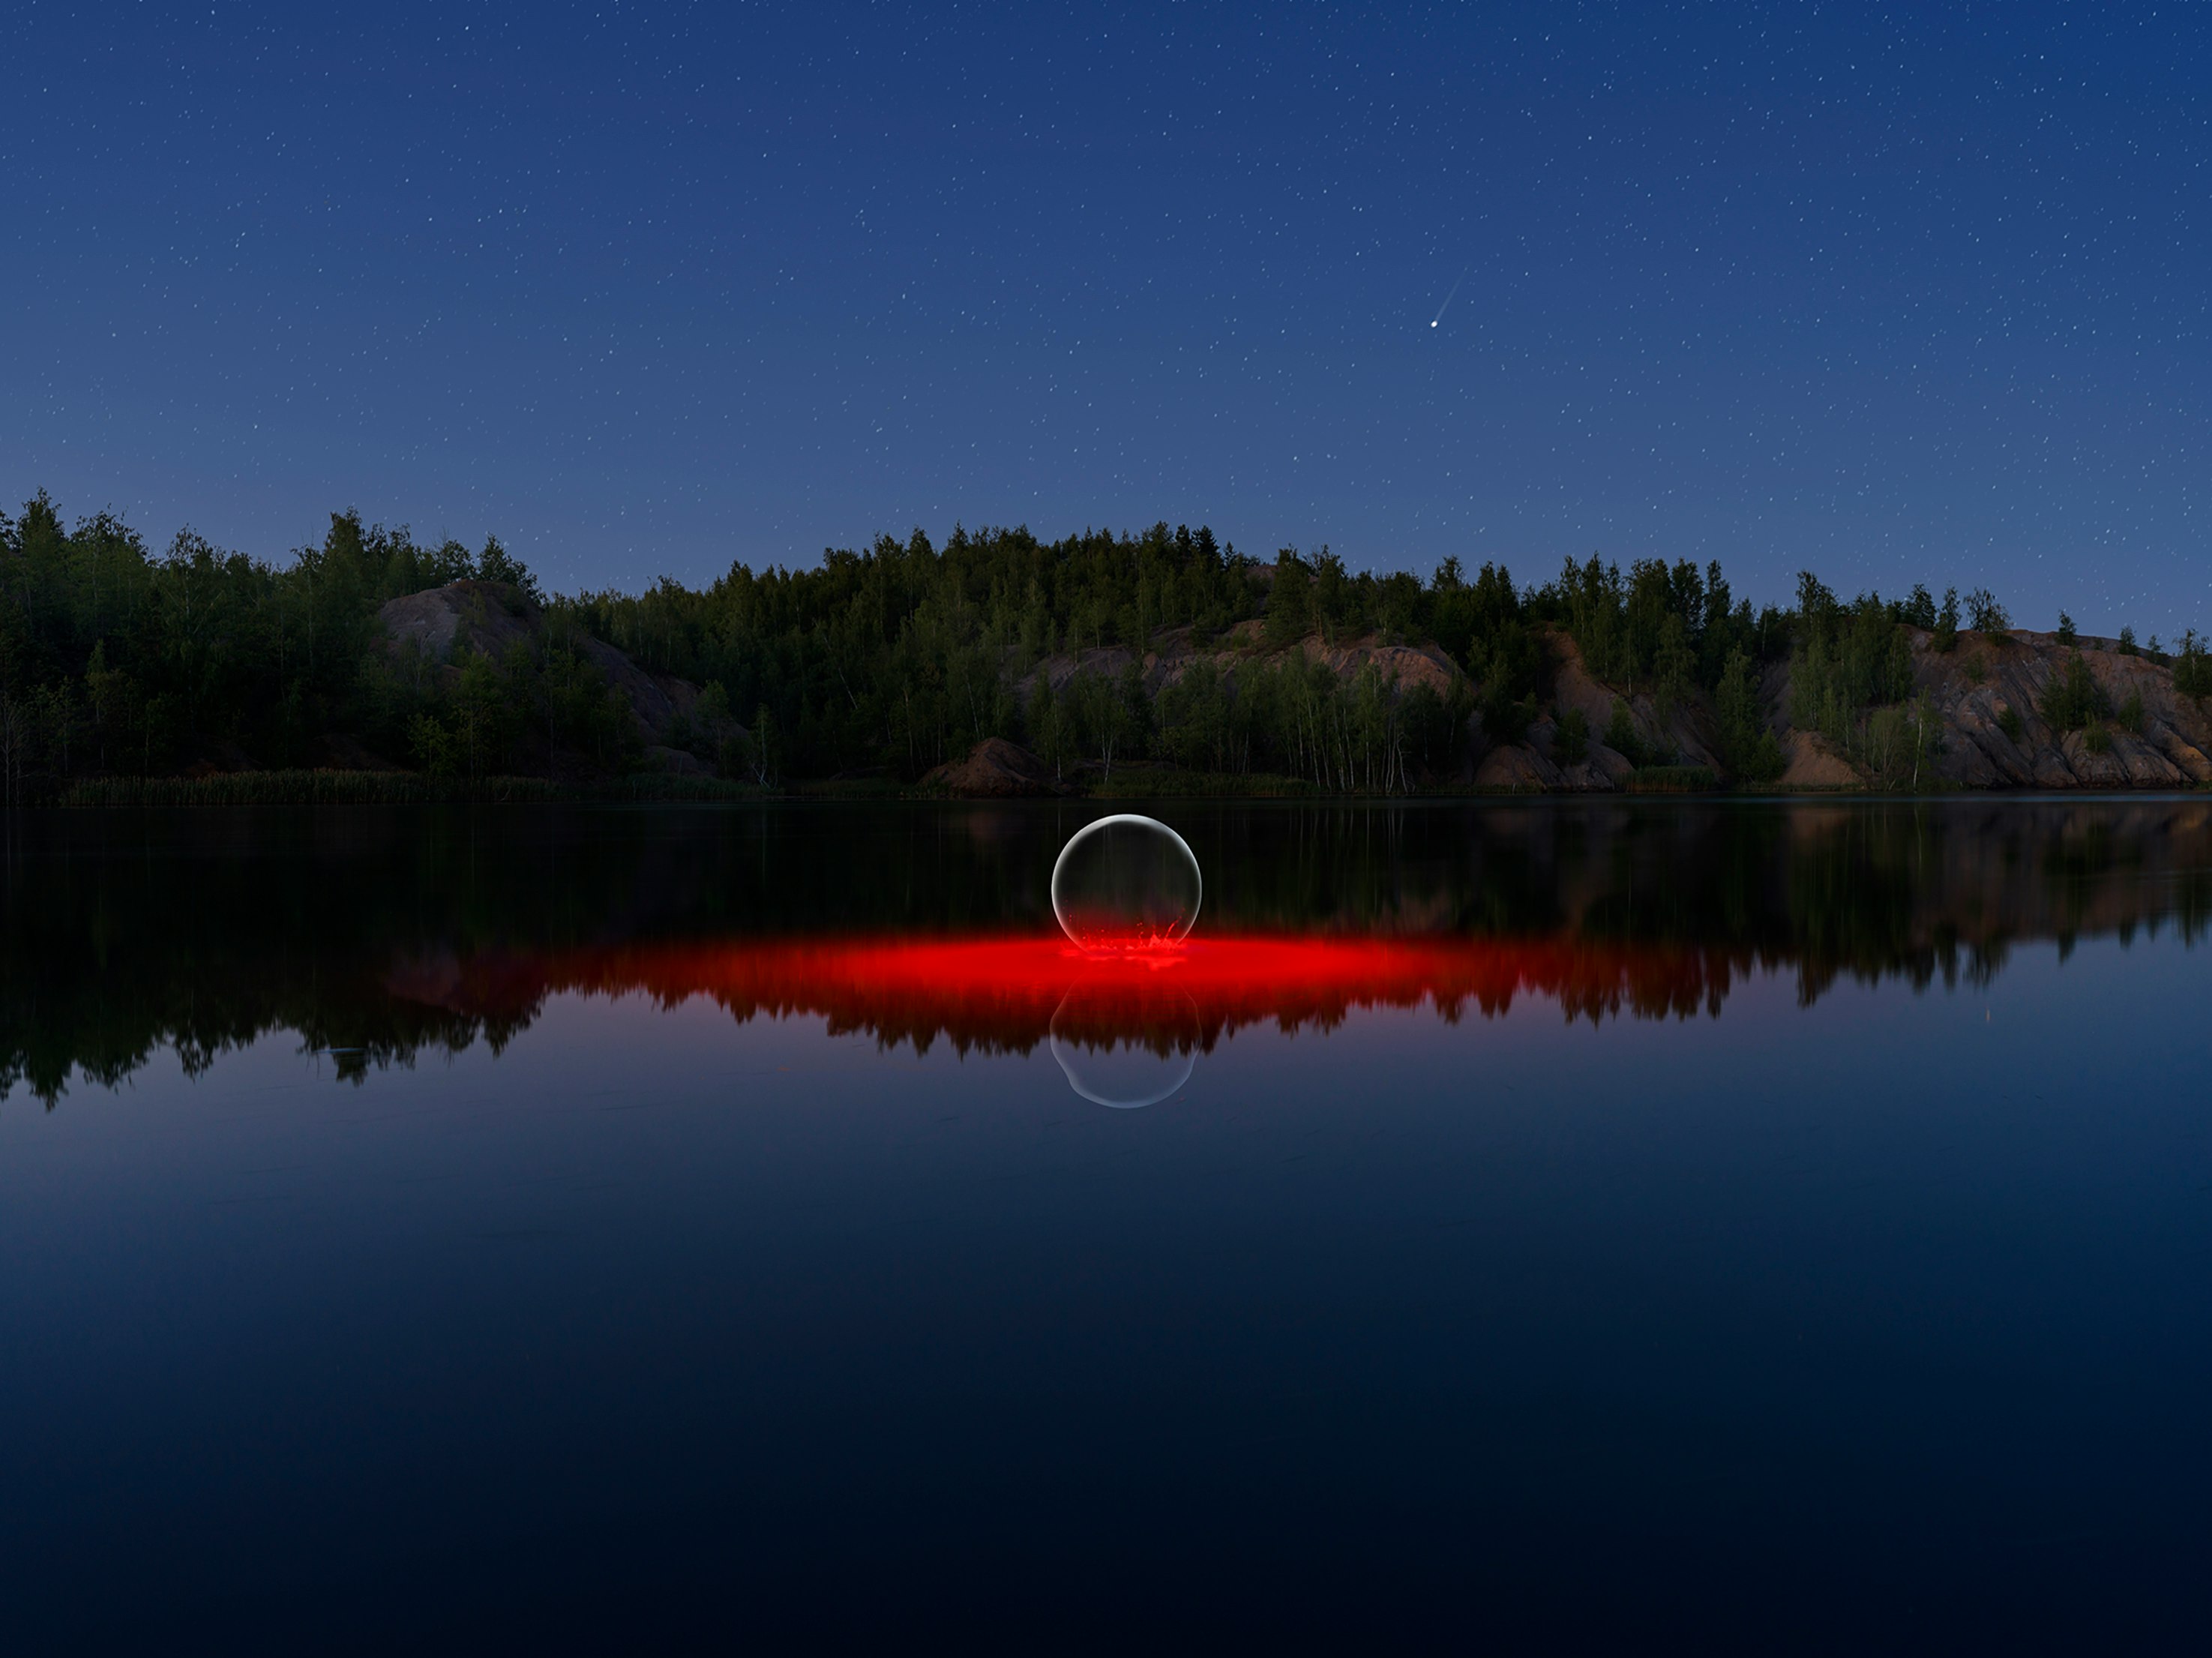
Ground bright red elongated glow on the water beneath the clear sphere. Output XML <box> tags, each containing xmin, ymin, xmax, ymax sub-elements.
<box><xmin>391</xmin><ymin>934</ymin><xmax>1752</xmax><ymax>1049</ymax></box>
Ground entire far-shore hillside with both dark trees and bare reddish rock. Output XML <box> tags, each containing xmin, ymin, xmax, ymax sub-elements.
<box><xmin>13</xmin><ymin>496</ymin><xmax>2212</xmax><ymax>804</ymax></box>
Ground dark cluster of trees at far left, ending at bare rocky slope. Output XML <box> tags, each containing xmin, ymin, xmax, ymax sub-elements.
<box><xmin>0</xmin><ymin>493</ymin><xmax>631</xmax><ymax>802</ymax></box>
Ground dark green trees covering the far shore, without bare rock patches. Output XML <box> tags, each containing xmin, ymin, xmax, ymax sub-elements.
<box><xmin>0</xmin><ymin>493</ymin><xmax>2212</xmax><ymax>802</ymax></box>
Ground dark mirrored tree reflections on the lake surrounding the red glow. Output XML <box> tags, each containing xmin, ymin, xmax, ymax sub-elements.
<box><xmin>0</xmin><ymin>799</ymin><xmax>2212</xmax><ymax>1102</ymax></box>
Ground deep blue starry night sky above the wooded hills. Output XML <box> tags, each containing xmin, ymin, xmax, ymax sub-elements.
<box><xmin>0</xmin><ymin>0</ymin><xmax>2212</xmax><ymax>628</ymax></box>
